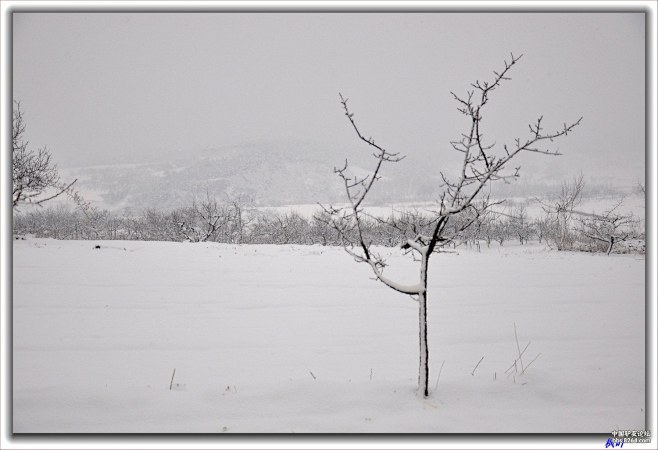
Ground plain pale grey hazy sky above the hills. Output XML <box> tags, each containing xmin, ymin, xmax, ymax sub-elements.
<box><xmin>13</xmin><ymin>12</ymin><xmax>645</xmax><ymax>182</ymax></box>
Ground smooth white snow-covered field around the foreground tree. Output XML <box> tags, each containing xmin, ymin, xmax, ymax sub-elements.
<box><xmin>13</xmin><ymin>239</ymin><xmax>645</xmax><ymax>432</ymax></box>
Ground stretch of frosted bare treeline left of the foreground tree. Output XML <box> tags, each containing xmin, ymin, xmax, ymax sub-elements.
<box><xmin>13</xmin><ymin>195</ymin><xmax>330</xmax><ymax>245</ymax></box>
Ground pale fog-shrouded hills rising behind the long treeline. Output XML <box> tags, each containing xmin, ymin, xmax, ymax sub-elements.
<box><xmin>60</xmin><ymin>141</ymin><xmax>632</xmax><ymax>210</ymax></box>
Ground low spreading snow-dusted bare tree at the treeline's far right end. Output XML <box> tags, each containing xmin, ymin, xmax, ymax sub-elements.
<box><xmin>579</xmin><ymin>199</ymin><xmax>642</xmax><ymax>255</ymax></box>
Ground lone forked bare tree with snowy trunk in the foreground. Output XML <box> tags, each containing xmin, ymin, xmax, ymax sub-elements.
<box><xmin>324</xmin><ymin>55</ymin><xmax>582</xmax><ymax>397</ymax></box>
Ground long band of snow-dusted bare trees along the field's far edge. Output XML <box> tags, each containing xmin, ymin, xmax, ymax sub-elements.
<box><xmin>13</xmin><ymin>196</ymin><xmax>644</xmax><ymax>253</ymax></box>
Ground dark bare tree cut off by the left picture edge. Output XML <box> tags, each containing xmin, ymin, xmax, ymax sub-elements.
<box><xmin>11</xmin><ymin>102</ymin><xmax>77</xmax><ymax>208</ymax></box>
